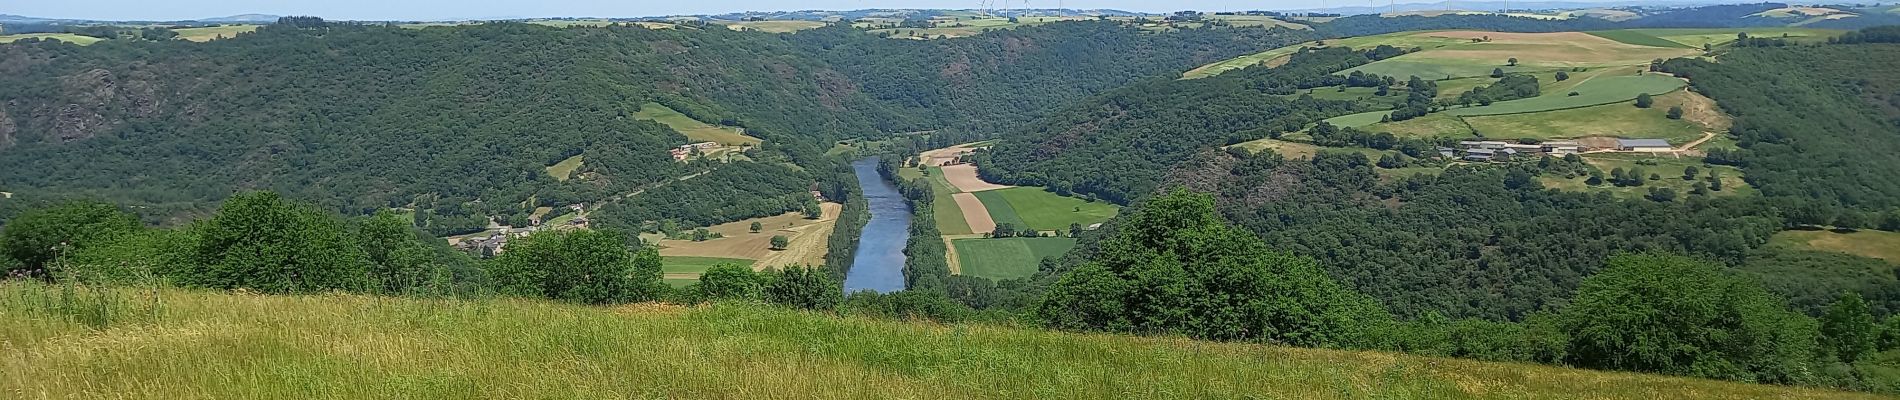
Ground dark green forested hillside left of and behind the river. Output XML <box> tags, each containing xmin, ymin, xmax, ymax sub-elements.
<box><xmin>0</xmin><ymin>19</ymin><xmax>1309</xmax><ymax>233</ymax></box>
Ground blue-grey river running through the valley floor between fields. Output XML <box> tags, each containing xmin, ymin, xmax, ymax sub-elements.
<box><xmin>844</xmin><ymin>157</ymin><xmax>910</xmax><ymax>294</ymax></box>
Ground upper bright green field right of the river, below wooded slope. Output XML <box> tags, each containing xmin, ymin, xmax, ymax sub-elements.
<box><xmin>977</xmin><ymin>188</ymin><xmax>1121</xmax><ymax>231</ymax></box>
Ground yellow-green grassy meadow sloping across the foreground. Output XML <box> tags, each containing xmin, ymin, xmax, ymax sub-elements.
<box><xmin>0</xmin><ymin>282</ymin><xmax>1875</xmax><ymax>400</ymax></box>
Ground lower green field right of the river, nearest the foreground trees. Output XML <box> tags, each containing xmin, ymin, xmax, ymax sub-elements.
<box><xmin>950</xmin><ymin>237</ymin><xmax>1075</xmax><ymax>281</ymax></box>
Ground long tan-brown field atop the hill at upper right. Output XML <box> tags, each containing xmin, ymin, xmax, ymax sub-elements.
<box><xmin>1406</xmin><ymin>30</ymin><xmax>1699</xmax><ymax>66</ymax></box>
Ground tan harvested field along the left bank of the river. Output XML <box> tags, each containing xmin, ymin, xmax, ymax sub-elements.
<box><xmin>659</xmin><ymin>203</ymin><xmax>844</xmax><ymax>269</ymax></box>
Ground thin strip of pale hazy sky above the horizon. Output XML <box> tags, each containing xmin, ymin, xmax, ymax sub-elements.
<box><xmin>0</xmin><ymin>0</ymin><xmax>1482</xmax><ymax>21</ymax></box>
